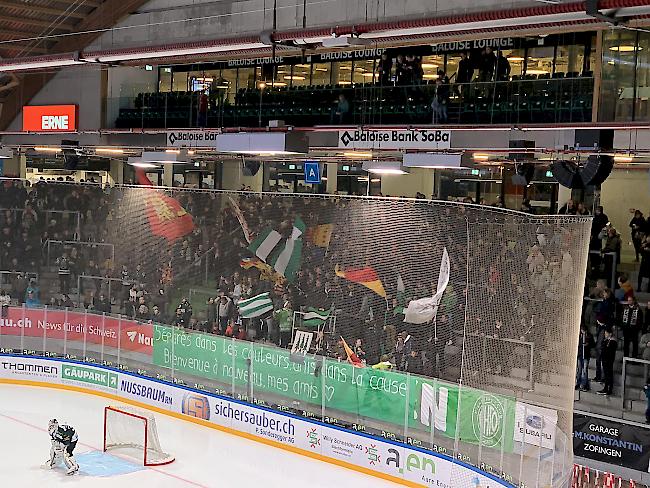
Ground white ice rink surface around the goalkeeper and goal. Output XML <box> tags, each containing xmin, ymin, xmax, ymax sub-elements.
<box><xmin>0</xmin><ymin>384</ymin><xmax>398</xmax><ymax>488</ymax></box>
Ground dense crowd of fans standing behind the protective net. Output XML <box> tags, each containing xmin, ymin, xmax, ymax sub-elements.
<box><xmin>0</xmin><ymin>177</ymin><xmax>588</xmax><ymax>394</ymax></box>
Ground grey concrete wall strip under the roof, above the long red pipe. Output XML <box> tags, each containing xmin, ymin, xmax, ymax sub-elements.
<box><xmin>87</xmin><ymin>0</ymin><xmax>539</xmax><ymax>49</ymax></box>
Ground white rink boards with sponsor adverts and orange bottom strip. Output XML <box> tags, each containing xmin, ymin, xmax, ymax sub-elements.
<box><xmin>0</xmin><ymin>354</ymin><xmax>511</xmax><ymax>488</ymax></box>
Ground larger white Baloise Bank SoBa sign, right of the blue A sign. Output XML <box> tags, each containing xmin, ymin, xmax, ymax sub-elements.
<box><xmin>339</xmin><ymin>129</ymin><xmax>451</xmax><ymax>149</ymax></box>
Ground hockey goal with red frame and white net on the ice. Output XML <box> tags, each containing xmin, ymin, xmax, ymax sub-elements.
<box><xmin>104</xmin><ymin>407</ymin><xmax>174</xmax><ymax>466</ymax></box>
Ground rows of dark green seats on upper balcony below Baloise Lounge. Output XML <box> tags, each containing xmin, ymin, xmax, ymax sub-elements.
<box><xmin>107</xmin><ymin>76</ymin><xmax>594</xmax><ymax>128</ymax></box>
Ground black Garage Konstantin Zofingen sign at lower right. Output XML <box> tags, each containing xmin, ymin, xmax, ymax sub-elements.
<box><xmin>573</xmin><ymin>413</ymin><xmax>650</xmax><ymax>472</ymax></box>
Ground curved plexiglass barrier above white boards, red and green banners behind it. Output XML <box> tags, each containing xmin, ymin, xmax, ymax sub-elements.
<box><xmin>0</xmin><ymin>306</ymin><xmax>573</xmax><ymax>488</ymax></box>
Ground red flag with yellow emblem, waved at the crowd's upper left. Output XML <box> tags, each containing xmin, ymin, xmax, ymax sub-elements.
<box><xmin>136</xmin><ymin>169</ymin><xmax>194</xmax><ymax>242</ymax></box>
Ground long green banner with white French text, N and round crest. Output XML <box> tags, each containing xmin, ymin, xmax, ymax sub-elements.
<box><xmin>153</xmin><ymin>326</ymin><xmax>515</xmax><ymax>452</ymax></box>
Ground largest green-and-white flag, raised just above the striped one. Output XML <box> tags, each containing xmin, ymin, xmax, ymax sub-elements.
<box><xmin>248</xmin><ymin>217</ymin><xmax>306</xmax><ymax>282</ymax></box>
